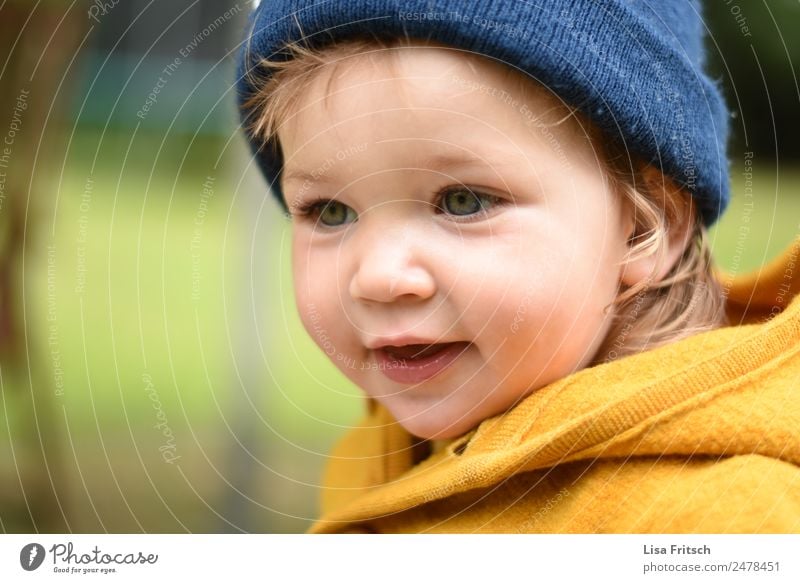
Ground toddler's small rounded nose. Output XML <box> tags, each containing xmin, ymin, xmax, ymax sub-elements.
<box><xmin>349</xmin><ymin>221</ymin><xmax>436</xmax><ymax>302</ymax></box>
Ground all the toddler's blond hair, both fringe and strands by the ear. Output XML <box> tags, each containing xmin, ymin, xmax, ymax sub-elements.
<box><xmin>244</xmin><ymin>38</ymin><xmax>727</xmax><ymax>365</ymax></box>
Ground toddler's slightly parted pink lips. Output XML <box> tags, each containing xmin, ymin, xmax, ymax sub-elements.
<box><xmin>375</xmin><ymin>342</ymin><xmax>471</xmax><ymax>384</ymax></box>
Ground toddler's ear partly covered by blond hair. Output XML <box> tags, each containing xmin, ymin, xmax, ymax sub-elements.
<box><xmin>620</xmin><ymin>166</ymin><xmax>696</xmax><ymax>287</ymax></box>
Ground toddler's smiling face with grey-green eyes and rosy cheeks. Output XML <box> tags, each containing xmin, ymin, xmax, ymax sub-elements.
<box><xmin>279</xmin><ymin>47</ymin><xmax>631</xmax><ymax>438</ymax></box>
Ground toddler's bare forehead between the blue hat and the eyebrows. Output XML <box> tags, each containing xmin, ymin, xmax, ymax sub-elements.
<box><xmin>279</xmin><ymin>45</ymin><xmax>567</xmax><ymax>143</ymax></box>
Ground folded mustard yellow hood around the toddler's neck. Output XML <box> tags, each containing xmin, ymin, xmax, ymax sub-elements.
<box><xmin>312</xmin><ymin>238</ymin><xmax>800</xmax><ymax>532</ymax></box>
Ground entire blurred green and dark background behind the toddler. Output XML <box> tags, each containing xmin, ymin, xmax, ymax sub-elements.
<box><xmin>0</xmin><ymin>0</ymin><xmax>800</xmax><ymax>532</ymax></box>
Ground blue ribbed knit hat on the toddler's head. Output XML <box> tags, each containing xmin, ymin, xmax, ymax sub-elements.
<box><xmin>238</xmin><ymin>0</ymin><xmax>729</xmax><ymax>225</ymax></box>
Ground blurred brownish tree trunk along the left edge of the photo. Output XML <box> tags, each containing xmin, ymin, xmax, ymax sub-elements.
<box><xmin>0</xmin><ymin>0</ymin><xmax>88</xmax><ymax>532</ymax></box>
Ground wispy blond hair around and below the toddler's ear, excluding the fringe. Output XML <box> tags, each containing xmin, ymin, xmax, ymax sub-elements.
<box><xmin>594</xmin><ymin>143</ymin><xmax>728</xmax><ymax>364</ymax></box>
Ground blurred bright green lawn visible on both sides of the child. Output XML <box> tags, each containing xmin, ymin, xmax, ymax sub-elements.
<box><xmin>6</xmin><ymin>135</ymin><xmax>800</xmax><ymax>532</ymax></box>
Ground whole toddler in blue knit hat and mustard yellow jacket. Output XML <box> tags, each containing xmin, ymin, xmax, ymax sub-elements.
<box><xmin>239</xmin><ymin>0</ymin><xmax>800</xmax><ymax>532</ymax></box>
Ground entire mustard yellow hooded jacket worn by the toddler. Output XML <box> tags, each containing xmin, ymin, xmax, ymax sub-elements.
<box><xmin>310</xmin><ymin>238</ymin><xmax>800</xmax><ymax>533</ymax></box>
